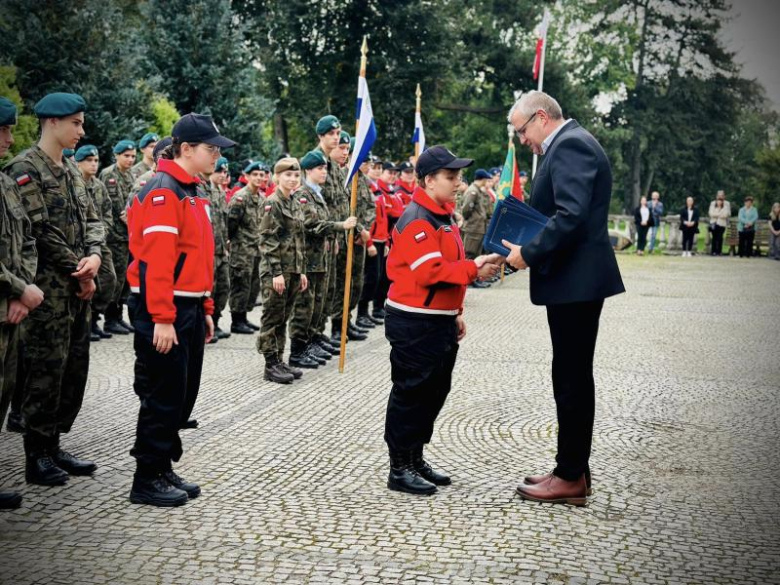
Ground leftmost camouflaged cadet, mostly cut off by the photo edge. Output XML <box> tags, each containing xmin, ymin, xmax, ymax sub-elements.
<box><xmin>0</xmin><ymin>98</ymin><xmax>43</xmax><ymax>510</ymax></box>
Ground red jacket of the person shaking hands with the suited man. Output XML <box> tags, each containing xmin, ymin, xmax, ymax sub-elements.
<box><xmin>387</xmin><ymin>187</ymin><xmax>477</xmax><ymax>315</ymax></box>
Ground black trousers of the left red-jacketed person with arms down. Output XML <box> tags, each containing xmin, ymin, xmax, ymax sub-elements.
<box><xmin>128</xmin><ymin>294</ymin><xmax>206</xmax><ymax>476</ymax></box>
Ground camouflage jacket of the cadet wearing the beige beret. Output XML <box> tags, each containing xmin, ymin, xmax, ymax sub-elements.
<box><xmin>256</xmin><ymin>189</ymin><xmax>306</xmax><ymax>276</ymax></box>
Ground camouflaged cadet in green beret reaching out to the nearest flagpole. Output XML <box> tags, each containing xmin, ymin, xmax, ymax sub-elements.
<box><xmin>290</xmin><ymin>150</ymin><xmax>356</xmax><ymax>365</ymax></box>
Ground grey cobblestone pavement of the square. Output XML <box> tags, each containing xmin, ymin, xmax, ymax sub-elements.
<box><xmin>0</xmin><ymin>256</ymin><xmax>780</xmax><ymax>585</ymax></box>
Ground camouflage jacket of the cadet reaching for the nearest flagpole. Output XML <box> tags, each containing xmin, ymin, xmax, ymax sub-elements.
<box><xmin>293</xmin><ymin>181</ymin><xmax>342</xmax><ymax>273</ymax></box>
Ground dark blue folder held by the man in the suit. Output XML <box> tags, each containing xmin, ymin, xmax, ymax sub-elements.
<box><xmin>483</xmin><ymin>197</ymin><xmax>547</xmax><ymax>256</ymax></box>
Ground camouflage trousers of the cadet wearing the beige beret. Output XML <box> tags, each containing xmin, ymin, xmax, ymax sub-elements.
<box><xmin>257</xmin><ymin>272</ymin><xmax>301</xmax><ymax>360</ymax></box>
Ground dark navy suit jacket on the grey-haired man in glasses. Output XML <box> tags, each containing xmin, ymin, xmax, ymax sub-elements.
<box><xmin>522</xmin><ymin>120</ymin><xmax>626</xmax><ymax>305</ymax></box>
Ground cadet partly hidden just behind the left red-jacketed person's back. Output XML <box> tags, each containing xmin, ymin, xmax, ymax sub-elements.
<box><xmin>204</xmin><ymin>157</ymin><xmax>230</xmax><ymax>340</ymax></box>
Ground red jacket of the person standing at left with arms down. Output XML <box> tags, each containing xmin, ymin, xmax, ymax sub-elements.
<box><xmin>127</xmin><ymin>159</ymin><xmax>214</xmax><ymax>323</ymax></box>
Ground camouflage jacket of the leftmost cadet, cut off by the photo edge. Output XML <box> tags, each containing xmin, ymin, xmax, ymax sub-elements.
<box><xmin>0</xmin><ymin>173</ymin><xmax>38</xmax><ymax>323</ymax></box>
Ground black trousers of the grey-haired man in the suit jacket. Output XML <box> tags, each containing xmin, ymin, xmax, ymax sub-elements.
<box><xmin>547</xmin><ymin>300</ymin><xmax>604</xmax><ymax>481</ymax></box>
